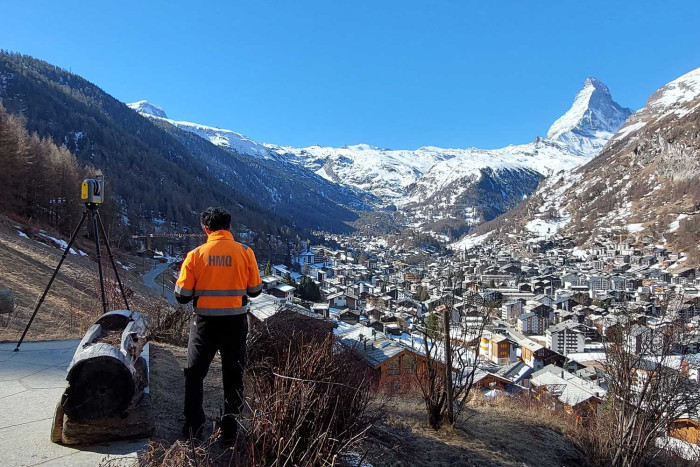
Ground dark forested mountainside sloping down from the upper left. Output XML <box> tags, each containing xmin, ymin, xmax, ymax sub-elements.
<box><xmin>0</xmin><ymin>52</ymin><xmax>356</xmax><ymax>232</ymax></box>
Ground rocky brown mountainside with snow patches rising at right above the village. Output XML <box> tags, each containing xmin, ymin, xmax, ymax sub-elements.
<box><xmin>456</xmin><ymin>69</ymin><xmax>700</xmax><ymax>265</ymax></box>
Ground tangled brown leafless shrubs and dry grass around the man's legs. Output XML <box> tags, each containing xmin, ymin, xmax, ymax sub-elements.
<box><xmin>141</xmin><ymin>314</ymin><xmax>381</xmax><ymax>466</ymax></box>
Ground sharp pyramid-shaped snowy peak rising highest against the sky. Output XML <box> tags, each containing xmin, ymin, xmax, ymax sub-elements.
<box><xmin>547</xmin><ymin>77</ymin><xmax>632</xmax><ymax>156</ymax></box>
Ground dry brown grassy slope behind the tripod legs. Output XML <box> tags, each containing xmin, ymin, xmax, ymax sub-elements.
<box><xmin>0</xmin><ymin>216</ymin><xmax>168</xmax><ymax>341</ymax></box>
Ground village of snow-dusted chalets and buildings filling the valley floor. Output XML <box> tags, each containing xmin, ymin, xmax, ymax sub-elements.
<box><xmin>251</xmin><ymin>228</ymin><xmax>700</xmax><ymax>454</ymax></box>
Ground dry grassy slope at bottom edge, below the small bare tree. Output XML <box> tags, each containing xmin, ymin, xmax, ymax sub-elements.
<box><xmin>364</xmin><ymin>394</ymin><xmax>591</xmax><ymax>467</ymax></box>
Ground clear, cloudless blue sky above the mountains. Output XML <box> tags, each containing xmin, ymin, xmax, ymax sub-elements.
<box><xmin>0</xmin><ymin>0</ymin><xmax>700</xmax><ymax>149</ymax></box>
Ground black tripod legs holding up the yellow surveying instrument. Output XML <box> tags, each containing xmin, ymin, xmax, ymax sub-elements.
<box><xmin>15</xmin><ymin>202</ymin><xmax>133</xmax><ymax>352</ymax></box>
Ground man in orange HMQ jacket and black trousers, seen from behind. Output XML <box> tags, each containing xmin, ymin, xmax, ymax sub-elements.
<box><xmin>175</xmin><ymin>208</ymin><xmax>262</xmax><ymax>443</ymax></box>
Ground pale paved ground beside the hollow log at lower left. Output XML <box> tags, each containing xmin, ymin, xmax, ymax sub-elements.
<box><xmin>0</xmin><ymin>339</ymin><xmax>147</xmax><ymax>467</ymax></box>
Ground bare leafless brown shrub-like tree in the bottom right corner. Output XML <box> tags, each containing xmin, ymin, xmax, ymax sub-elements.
<box><xmin>598</xmin><ymin>298</ymin><xmax>700</xmax><ymax>466</ymax></box>
